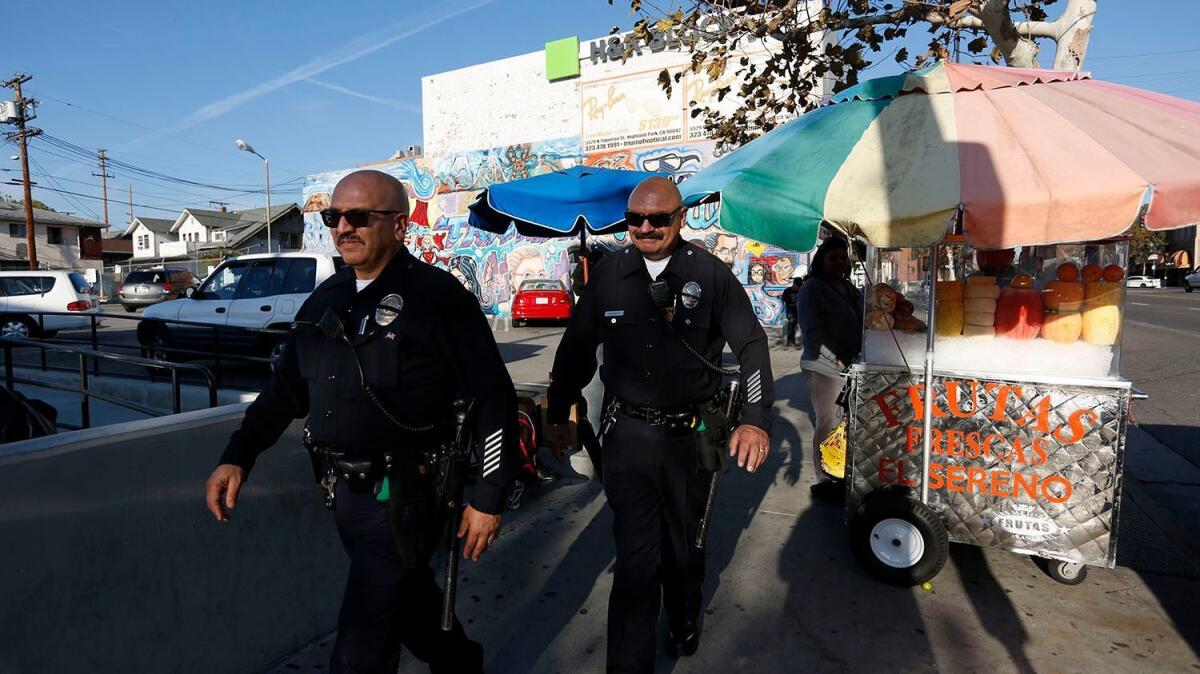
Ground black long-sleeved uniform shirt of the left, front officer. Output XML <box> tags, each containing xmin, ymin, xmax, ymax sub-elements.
<box><xmin>221</xmin><ymin>249</ymin><xmax>520</xmax><ymax>514</ymax></box>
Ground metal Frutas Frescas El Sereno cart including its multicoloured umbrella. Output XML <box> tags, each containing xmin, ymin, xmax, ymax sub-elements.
<box><xmin>679</xmin><ymin>62</ymin><xmax>1200</xmax><ymax>584</ymax></box>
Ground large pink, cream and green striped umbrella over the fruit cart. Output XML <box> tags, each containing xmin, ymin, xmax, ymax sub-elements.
<box><xmin>680</xmin><ymin>62</ymin><xmax>1200</xmax><ymax>251</ymax></box>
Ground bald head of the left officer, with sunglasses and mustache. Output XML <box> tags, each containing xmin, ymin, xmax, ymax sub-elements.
<box><xmin>330</xmin><ymin>170</ymin><xmax>408</xmax><ymax>273</ymax></box>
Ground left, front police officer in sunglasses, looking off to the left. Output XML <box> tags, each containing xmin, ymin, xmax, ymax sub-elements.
<box><xmin>208</xmin><ymin>170</ymin><xmax>518</xmax><ymax>674</ymax></box>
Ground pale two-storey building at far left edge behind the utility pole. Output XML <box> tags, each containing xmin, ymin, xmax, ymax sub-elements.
<box><xmin>0</xmin><ymin>199</ymin><xmax>107</xmax><ymax>270</ymax></box>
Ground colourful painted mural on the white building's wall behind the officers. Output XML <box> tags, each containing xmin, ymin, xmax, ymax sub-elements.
<box><xmin>302</xmin><ymin>138</ymin><xmax>806</xmax><ymax>326</ymax></box>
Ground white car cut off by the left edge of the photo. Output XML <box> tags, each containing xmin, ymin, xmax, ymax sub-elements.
<box><xmin>0</xmin><ymin>271</ymin><xmax>100</xmax><ymax>337</ymax></box>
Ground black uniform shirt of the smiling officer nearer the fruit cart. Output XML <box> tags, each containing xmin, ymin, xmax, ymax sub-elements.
<box><xmin>547</xmin><ymin>241</ymin><xmax>775</xmax><ymax>431</ymax></box>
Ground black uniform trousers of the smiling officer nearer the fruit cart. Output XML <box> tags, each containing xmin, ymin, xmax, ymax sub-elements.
<box><xmin>604</xmin><ymin>414</ymin><xmax>710</xmax><ymax>673</ymax></box>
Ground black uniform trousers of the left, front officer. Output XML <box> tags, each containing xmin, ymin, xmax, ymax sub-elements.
<box><xmin>329</xmin><ymin>481</ymin><xmax>484</xmax><ymax>674</ymax></box>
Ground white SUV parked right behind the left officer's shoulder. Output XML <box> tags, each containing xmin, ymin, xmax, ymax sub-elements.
<box><xmin>138</xmin><ymin>253</ymin><xmax>344</xmax><ymax>360</ymax></box>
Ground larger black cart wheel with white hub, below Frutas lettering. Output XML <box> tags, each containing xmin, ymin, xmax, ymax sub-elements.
<box><xmin>850</xmin><ymin>493</ymin><xmax>950</xmax><ymax>588</ymax></box>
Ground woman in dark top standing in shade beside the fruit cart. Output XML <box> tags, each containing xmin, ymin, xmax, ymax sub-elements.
<box><xmin>796</xmin><ymin>236</ymin><xmax>863</xmax><ymax>504</ymax></box>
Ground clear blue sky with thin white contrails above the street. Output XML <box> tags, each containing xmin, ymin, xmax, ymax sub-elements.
<box><xmin>0</xmin><ymin>0</ymin><xmax>1200</xmax><ymax>224</ymax></box>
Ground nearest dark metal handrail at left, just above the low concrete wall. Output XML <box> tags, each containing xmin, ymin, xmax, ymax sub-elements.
<box><xmin>0</xmin><ymin>337</ymin><xmax>217</xmax><ymax>428</ymax></box>
